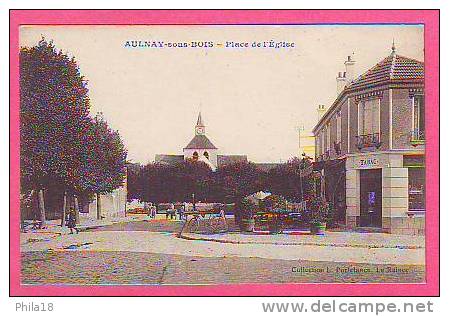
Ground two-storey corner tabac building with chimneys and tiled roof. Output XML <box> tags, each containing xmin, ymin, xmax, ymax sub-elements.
<box><xmin>313</xmin><ymin>45</ymin><xmax>425</xmax><ymax>234</ymax></box>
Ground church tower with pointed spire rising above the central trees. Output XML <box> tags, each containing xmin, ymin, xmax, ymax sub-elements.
<box><xmin>183</xmin><ymin>112</ymin><xmax>218</xmax><ymax>171</ymax></box>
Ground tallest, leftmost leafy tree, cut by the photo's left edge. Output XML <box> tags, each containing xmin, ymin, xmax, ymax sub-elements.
<box><xmin>20</xmin><ymin>39</ymin><xmax>90</xmax><ymax>225</ymax></box>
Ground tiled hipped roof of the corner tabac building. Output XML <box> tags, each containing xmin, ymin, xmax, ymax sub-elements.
<box><xmin>347</xmin><ymin>52</ymin><xmax>424</xmax><ymax>89</ymax></box>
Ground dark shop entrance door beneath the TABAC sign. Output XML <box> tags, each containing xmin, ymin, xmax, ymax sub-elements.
<box><xmin>360</xmin><ymin>169</ymin><xmax>382</xmax><ymax>228</ymax></box>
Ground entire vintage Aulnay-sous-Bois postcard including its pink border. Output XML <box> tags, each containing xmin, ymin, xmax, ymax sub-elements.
<box><xmin>11</xmin><ymin>10</ymin><xmax>439</xmax><ymax>296</ymax></box>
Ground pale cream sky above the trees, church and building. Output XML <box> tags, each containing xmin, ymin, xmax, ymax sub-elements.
<box><xmin>20</xmin><ymin>25</ymin><xmax>424</xmax><ymax>163</ymax></box>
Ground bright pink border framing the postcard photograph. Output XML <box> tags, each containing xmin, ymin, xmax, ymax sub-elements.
<box><xmin>10</xmin><ymin>10</ymin><xmax>440</xmax><ymax>296</ymax></box>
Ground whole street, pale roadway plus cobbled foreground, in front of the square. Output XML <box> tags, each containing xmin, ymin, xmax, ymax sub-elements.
<box><xmin>22</xmin><ymin>220</ymin><xmax>425</xmax><ymax>284</ymax></box>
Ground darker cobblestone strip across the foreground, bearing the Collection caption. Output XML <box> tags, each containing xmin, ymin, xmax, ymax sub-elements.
<box><xmin>22</xmin><ymin>251</ymin><xmax>424</xmax><ymax>285</ymax></box>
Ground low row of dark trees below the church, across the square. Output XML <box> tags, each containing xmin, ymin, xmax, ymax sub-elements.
<box><xmin>128</xmin><ymin>158</ymin><xmax>315</xmax><ymax>203</ymax></box>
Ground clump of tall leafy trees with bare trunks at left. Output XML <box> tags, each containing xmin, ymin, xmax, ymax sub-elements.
<box><xmin>20</xmin><ymin>39</ymin><xmax>127</xmax><ymax>225</ymax></box>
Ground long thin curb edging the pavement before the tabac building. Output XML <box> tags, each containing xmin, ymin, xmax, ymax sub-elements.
<box><xmin>178</xmin><ymin>234</ymin><xmax>425</xmax><ymax>250</ymax></box>
